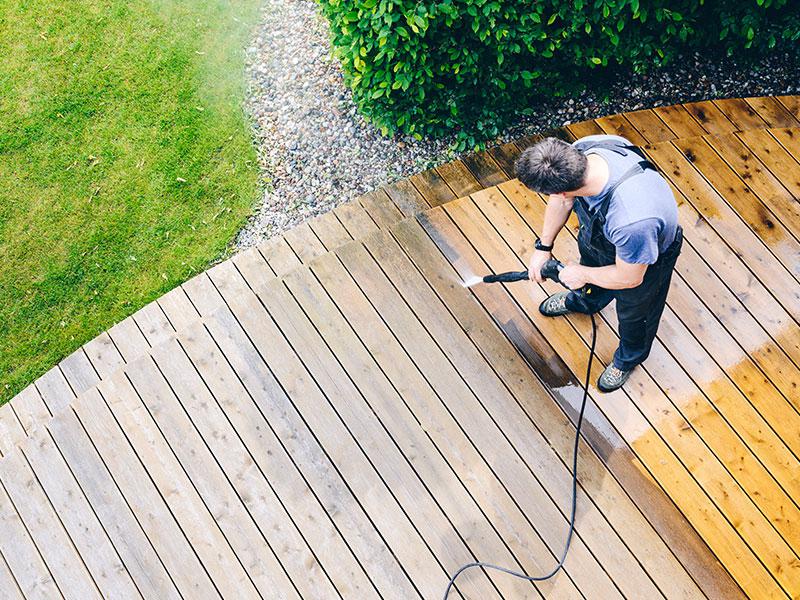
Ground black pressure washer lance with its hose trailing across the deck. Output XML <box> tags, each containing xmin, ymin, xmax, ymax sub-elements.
<box><xmin>443</xmin><ymin>258</ymin><xmax>597</xmax><ymax>600</ymax></box>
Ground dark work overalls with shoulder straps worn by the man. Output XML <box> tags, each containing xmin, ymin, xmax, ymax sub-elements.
<box><xmin>566</xmin><ymin>142</ymin><xmax>683</xmax><ymax>371</ymax></box>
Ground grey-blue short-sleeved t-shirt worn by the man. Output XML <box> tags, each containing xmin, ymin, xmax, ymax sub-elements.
<box><xmin>574</xmin><ymin>135</ymin><xmax>678</xmax><ymax>264</ymax></box>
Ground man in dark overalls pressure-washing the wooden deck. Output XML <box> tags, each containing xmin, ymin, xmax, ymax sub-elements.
<box><xmin>515</xmin><ymin>135</ymin><xmax>683</xmax><ymax>392</ymax></box>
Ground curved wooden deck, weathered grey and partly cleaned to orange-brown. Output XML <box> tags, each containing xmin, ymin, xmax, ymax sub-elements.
<box><xmin>0</xmin><ymin>97</ymin><xmax>800</xmax><ymax>600</ymax></box>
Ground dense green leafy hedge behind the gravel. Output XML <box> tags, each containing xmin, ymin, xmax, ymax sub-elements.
<box><xmin>320</xmin><ymin>0</ymin><xmax>800</xmax><ymax>147</ymax></box>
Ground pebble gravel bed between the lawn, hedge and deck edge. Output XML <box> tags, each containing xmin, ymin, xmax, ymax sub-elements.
<box><xmin>236</xmin><ymin>0</ymin><xmax>800</xmax><ymax>249</ymax></box>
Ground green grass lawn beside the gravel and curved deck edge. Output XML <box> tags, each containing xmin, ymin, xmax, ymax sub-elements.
<box><xmin>0</xmin><ymin>0</ymin><xmax>259</xmax><ymax>403</ymax></box>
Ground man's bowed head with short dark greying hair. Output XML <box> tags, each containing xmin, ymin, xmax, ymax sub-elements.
<box><xmin>514</xmin><ymin>138</ymin><xmax>588</xmax><ymax>194</ymax></box>
